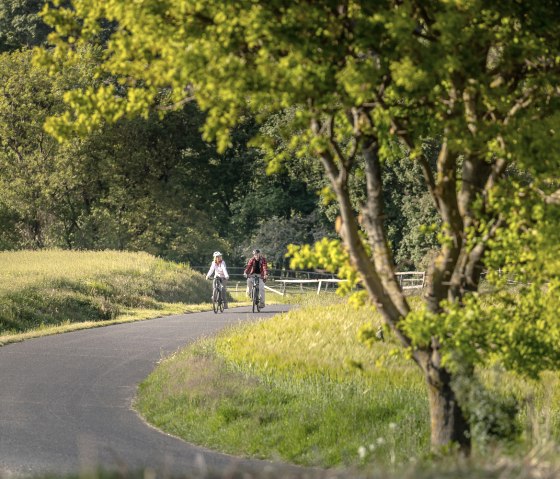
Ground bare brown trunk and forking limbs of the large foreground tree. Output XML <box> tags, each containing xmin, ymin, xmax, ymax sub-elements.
<box><xmin>312</xmin><ymin>114</ymin><xmax>471</xmax><ymax>455</ymax></box>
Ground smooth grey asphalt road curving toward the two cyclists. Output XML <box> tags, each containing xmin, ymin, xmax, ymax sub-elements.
<box><xmin>0</xmin><ymin>305</ymin><xmax>298</xmax><ymax>477</ymax></box>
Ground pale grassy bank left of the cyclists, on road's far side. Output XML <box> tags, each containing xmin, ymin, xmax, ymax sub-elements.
<box><xmin>0</xmin><ymin>250</ymin><xmax>214</xmax><ymax>344</ymax></box>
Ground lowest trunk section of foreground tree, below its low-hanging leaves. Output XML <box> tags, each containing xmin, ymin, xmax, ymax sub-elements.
<box><xmin>426</xmin><ymin>369</ymin><xmax>471</xmax><ymax>456</ymax></box>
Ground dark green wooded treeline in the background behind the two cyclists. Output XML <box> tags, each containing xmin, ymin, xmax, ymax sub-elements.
<box><xmin>0</xmin><ymin>0</ymin><xmax>435</xmax><ymax>269</ymax></box>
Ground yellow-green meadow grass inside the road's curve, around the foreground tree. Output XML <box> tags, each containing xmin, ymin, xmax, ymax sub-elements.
<box><xmin>136</xmin><ymin>296</ymin><xmax>560</xmax><ymax>477</ymax></box>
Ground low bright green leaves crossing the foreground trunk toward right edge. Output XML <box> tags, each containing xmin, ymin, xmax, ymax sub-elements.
<box><xmin>400</xmin><ymin>280</ymin><xmax>560</xmax><ymax>378</ymax></box>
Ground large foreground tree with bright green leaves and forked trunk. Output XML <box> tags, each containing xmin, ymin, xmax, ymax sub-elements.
<box><xmin>41</xmin><ymin>0</ymin><xmax>560</xmax><ymax>452</ymax></box>
